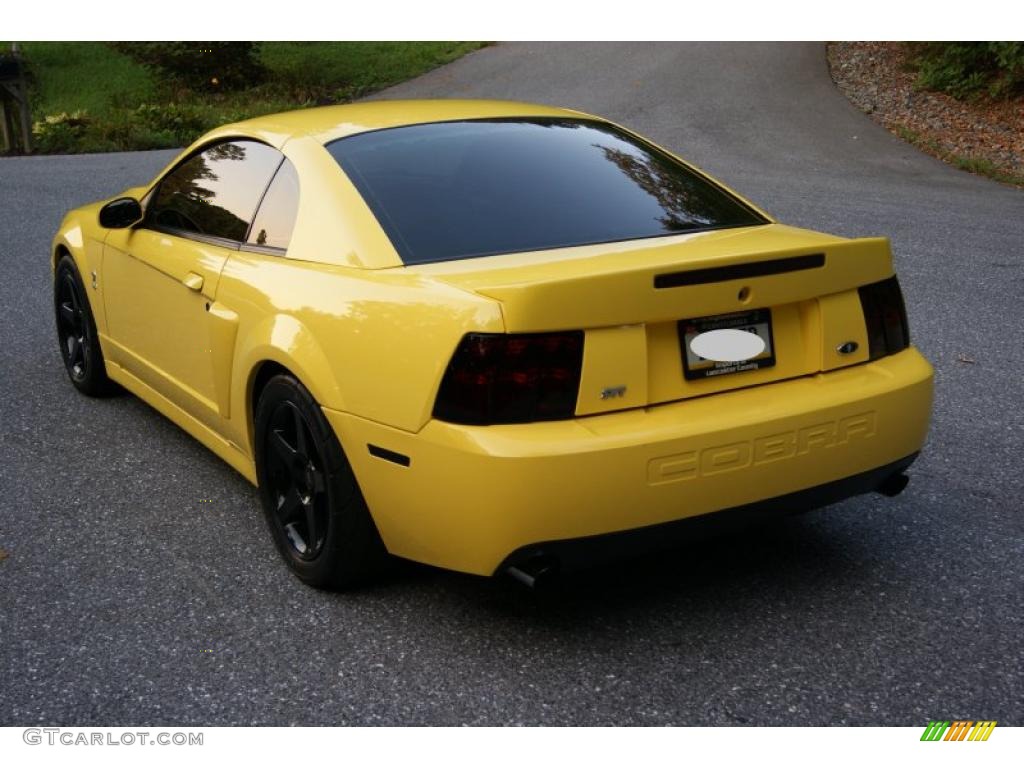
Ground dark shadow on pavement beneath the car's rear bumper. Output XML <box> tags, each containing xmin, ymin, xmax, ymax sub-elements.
<box><xmin>378</xmin><ymin>510</ymin><xmax>868</xmax><ymax>624</ymax></box>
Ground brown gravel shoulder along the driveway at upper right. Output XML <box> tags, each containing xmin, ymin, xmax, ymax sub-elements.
<box><xmin>828</xmin><ymin>42</ymin><xmax>1024</xmax><ymax>186</ymax></box>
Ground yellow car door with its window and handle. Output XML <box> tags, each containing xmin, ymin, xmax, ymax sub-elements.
<box><xmin>102</xmin><ymin>139</ymin><xmax>284</xmax><ymax>431</ymax></box>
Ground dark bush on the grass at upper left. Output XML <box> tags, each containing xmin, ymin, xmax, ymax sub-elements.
<box><xmin>110</xmin><ymin>42</ymin><xmax>266</xmax><ymax>91</ymax></box>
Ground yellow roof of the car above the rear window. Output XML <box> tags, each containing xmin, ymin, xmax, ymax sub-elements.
<box><xmin>218</xmin><ymin>99</ymin><xmax>591</xmax><ymax>145</ymax></box>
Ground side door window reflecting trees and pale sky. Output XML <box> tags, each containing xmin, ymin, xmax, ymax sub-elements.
<box><xmin>146</xmin><ymin>140</ymin><xmax>282</xmax><ymax>242</ymax></box>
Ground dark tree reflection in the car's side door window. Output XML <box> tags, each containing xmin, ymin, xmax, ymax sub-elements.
<box><xmin>154</xmin><ymin>142</ymin><xmax>249</xmax><ymax>241</ymax></box>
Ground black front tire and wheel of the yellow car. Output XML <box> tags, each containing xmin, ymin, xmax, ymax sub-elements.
<box><xmin>53</xmin><ymin>254</ymin><xmax>118</xmax><ymax>397</ymax></box>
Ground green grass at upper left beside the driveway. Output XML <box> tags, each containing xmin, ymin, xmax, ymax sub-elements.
<box><xmin>0</xmin><ymin>42</ymin><xmax>483</xmax><ymax>153</ymax></box>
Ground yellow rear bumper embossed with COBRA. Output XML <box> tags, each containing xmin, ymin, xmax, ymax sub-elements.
<box><xmin>325</xmin><ymin>348</ymin><xmax>932</xmax><ymax>574</ymax></box>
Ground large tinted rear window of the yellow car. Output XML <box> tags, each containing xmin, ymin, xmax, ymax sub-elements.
<box><xmin>327</xmin><ymin>118</ymin><xmax>767</xmax><ymax>264</ymax></box>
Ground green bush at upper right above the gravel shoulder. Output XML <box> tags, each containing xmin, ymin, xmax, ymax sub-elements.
<box><xmin>910</xmin><ymin>42</ymin><xmax>1024</xmax><ymax>98</ymax></box>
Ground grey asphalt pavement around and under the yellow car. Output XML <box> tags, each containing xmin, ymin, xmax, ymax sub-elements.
<box><xmin>0</xmin><ymin>43</ymin><xmax>1024</xmax><ymax>727</ymax></box>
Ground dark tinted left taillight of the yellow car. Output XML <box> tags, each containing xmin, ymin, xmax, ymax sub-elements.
<box><xmin>434</xmin><ymin>331</ymin><xmax>583</xmax><ymax>424</ymax></box>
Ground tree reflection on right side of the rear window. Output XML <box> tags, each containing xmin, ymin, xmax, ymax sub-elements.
<box><xmin>595</xmin><ymin>144</ymin><xmax>736</xmax><ymax>231</ymax></box>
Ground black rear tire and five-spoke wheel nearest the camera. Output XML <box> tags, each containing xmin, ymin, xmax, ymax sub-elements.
<box><xmin>255</xmin><ymin>374</ymin><xmax>389</xmax><ymax>590</ymax></box>
